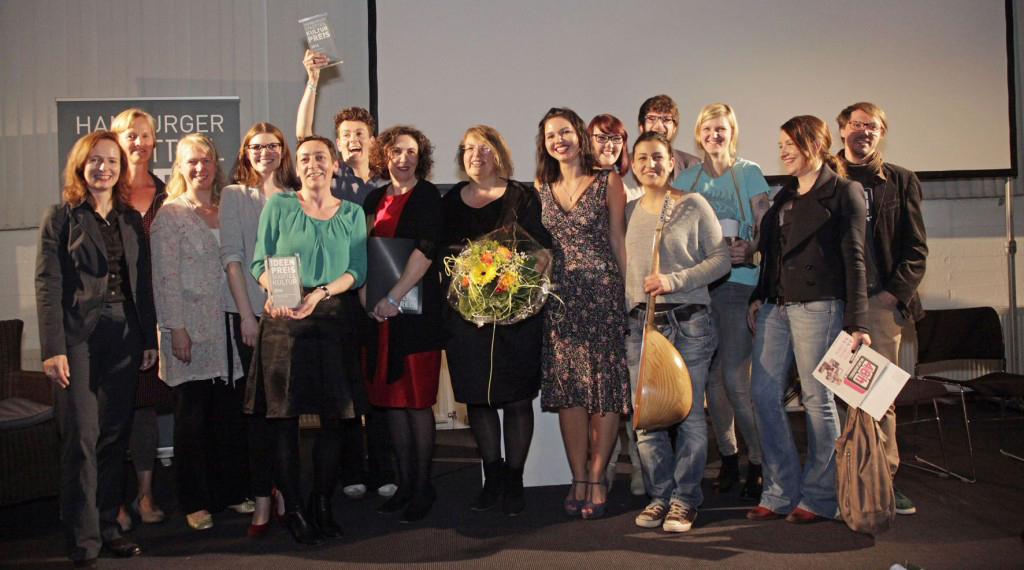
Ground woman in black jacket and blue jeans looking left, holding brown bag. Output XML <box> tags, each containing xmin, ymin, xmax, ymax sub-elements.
<box><xmin>746</xmin><ymin>116</ymin><xmax>870</xmax><ymax>523</ymax></box>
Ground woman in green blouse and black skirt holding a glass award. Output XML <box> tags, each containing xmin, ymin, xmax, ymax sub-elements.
<box><xmin>246</xmin><ymin>135</ymin><xmax>367</xmax><ymax>544</ymax></box>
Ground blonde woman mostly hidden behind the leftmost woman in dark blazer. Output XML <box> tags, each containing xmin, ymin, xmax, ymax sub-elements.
<box><xmin>111</xmin><ymin>108</ymin><xmax>171</xmax><ymax>530</ymax></box>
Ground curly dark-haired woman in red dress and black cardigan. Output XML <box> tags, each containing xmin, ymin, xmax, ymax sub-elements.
<box><xmin>359</xmin><ymin>125</ymin><xmax>444</xmax><ymax>523</ymax></box>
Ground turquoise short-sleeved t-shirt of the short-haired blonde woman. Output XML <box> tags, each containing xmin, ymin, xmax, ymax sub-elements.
<box><xmin>672</xmin><ymin>159</ymin><xmax>769</xmax><ymax>286</ymax></box>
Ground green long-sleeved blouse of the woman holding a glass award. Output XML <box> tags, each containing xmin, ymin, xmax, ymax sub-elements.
<box><xmin>251</xmin><ymin>192</ymin><xmax>367</xmax><ymax>289</ymax></box>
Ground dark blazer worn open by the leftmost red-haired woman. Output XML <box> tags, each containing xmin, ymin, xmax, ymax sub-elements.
<box><xmin>36</xmin><ymin>201</ymin><xmax>157</xmax><ymax>360</ymax></box>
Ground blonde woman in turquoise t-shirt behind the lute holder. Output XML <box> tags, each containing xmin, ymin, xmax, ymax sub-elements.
<box><xmin>673</xmin><ymin>103</ymin><xmax>768</xmax><ymax>500</ymax></box>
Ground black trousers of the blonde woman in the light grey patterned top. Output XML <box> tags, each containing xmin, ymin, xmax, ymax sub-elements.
<box><xmin>171</xmin><ymin>378</ymin><xmax>249</xmax><ymax>514</ymax></box>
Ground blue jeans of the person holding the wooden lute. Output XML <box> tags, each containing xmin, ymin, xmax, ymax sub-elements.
<box><xmin>626</xmin><ymin>309</ymin><xmax>718</xmax><ymax>509</ymax></box>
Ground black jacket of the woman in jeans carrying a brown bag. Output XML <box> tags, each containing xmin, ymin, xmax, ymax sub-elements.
<box><xmin>751</xmin><ymin>165</ymin><xmax>867</xmax><ymax>332</ymax></box>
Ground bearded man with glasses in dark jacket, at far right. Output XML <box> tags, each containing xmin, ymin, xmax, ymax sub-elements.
<box><xmin>836</xmin><ymin>102</ymin><xmax>928</xmax><ymax>515</ymax></box>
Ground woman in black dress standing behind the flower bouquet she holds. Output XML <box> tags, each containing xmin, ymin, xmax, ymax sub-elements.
<box><xmin>442</xmin><ymin>125</ymin><xmax>551</xmax><ymax>515</ymax></box>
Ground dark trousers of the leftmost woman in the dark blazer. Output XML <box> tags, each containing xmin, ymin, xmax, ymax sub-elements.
<box><xmin>56</xmin><ymin>303</ymin><xmax>142</xmax><ymax>560</ymax></box>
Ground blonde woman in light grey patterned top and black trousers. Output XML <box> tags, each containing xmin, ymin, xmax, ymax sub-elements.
<box><xmin>153</xmin><ymin>134</ymin><xmax>245</xmax><ymax>530</ymax></box>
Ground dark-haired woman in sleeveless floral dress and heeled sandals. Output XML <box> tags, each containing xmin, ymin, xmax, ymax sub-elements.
<box><xmin>536</xmin><ymin>108</ymin><xmax>632</xmax><ymax>519</ymax></box>
